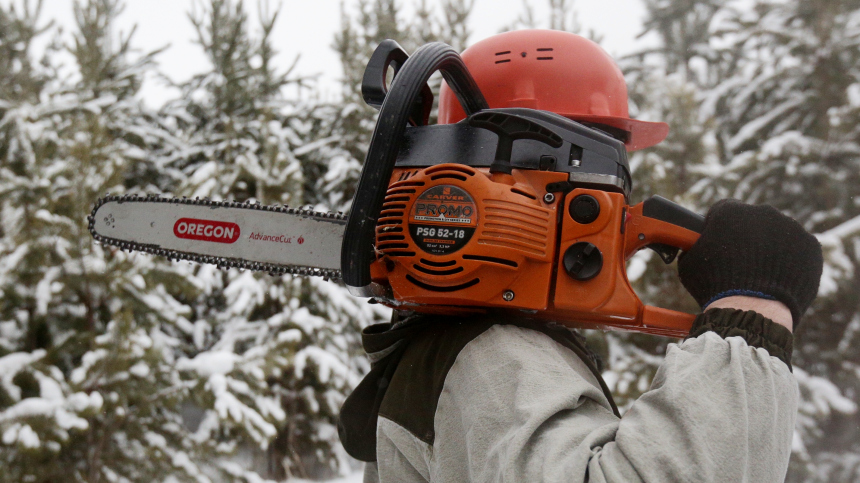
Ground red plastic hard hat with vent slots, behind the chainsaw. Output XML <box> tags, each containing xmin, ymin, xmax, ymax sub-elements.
<box><xmin>439</xmin><ymin>30</ymin><xmax>669</xmax><ymax>151</ymax></box>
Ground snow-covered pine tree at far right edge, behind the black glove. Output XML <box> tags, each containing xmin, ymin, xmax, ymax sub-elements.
<box><xmin>693</xmin><ymin>0</ymin><xmax>860</xmax><ymax>482</ymax></box>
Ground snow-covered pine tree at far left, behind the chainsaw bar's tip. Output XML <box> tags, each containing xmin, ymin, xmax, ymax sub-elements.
<box><xmin>0</xmin><ymin>0</ymin><xmax>213</xmax><ymax>482</ymax></box>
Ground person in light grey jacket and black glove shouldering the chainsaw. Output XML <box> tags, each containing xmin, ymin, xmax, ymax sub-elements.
<box><xmin>339</xmin><ymin>30</ymin><xmax>823</xmax><ymax>483</ymax></box>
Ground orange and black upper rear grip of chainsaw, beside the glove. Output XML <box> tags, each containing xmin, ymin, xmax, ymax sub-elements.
<box><xmin>623</xmin><ymin>196</ymin><xmax>705</xmax><ymax>260</ymax></box>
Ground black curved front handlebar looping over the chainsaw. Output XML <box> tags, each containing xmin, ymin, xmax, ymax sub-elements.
<box><xmin>341</xmin><ymin>42</ymin><xmax>489</xmax><ymax>297</ymax></box>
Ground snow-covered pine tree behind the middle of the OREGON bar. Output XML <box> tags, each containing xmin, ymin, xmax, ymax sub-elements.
<box><xmin>161</xmin><ymin>0</ymin><xmax>385</xmax><ymax>481</ymax></box>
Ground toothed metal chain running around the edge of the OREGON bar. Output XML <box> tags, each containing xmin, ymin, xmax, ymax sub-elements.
<box><xmin>87</xmin><ymin>193</ymin><xmax>347</xmax><ymax>280</ymax></box>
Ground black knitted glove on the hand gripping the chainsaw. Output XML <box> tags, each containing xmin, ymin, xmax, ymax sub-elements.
<box><xmin>678</xmin><ymin>200</ymin><xmax>824</xmax><ymax>328</ymax></box>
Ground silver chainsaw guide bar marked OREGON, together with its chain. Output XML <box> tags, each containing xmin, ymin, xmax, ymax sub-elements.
<box><xmin>87</xmin><ymin>194</ymin><xmax>347</xmax><ymax>279</ymax></box>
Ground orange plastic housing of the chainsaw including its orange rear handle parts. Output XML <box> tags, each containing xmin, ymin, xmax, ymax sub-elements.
<box><xmin>371</xmin><ymin>163</ymin><xmax>699</xmax><ymax>337</ymax></box>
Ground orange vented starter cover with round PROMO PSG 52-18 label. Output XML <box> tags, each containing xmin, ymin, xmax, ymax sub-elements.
<box><xmin>376</xmin><ymin>164</ymin><xmax>567</xmax><ymax>310</ymax></box>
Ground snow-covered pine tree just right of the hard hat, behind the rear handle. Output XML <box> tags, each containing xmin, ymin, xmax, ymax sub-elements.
<box><xmin>606</xmin><ymin>0</ymin><xmax>727</xmax><ymax>406</ymax></box>
